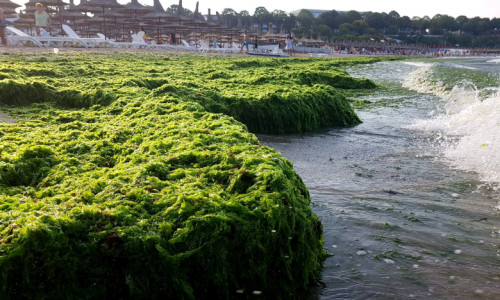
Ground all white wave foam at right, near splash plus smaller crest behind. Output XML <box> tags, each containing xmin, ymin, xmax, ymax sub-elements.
<box><xmin>404</xmin><ymin>65</ymin><xmax>500</xmax><ymax>183</ymax></box>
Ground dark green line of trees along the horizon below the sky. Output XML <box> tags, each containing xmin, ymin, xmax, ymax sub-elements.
<box><xmin>209</xmin><ymin>6</ymin><xmax>500</xmax><ymax>48</ymax></box>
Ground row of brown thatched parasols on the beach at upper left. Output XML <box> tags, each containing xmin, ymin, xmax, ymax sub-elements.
<box><xmin>0</xmin><ymin>0</ymin><xmax>254</xmax><ymax>43</ymax></box>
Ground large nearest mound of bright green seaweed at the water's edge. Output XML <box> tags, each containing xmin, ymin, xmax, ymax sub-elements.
<box><xmin>0</xmin><ymin>106</ymin><xmax>325</xmax><ymax>299</ymax></box>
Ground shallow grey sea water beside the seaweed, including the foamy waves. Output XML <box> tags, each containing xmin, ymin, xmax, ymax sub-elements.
<box><xmin>259</xmin><ymin>59</ymin><xmax>500</xmax><ymax>299</ymax></box>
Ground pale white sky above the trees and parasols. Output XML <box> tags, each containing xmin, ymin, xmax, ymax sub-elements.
<box><xmin>9</xmin><ymin>0</ymin><xmax>500</xmax><ymax>19</ymax></box>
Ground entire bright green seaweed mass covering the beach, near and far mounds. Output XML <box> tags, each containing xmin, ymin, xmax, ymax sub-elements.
<box><xmin>0</xmin><ymin>53</ymin><xmax>382</xmax><ymax>299</ymax></box>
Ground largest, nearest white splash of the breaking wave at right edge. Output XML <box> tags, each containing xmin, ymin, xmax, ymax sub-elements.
<box><xmin>409</xmin><ymin>88</ymin><xmax>500</xmax><ymax>183</ymax></box>
